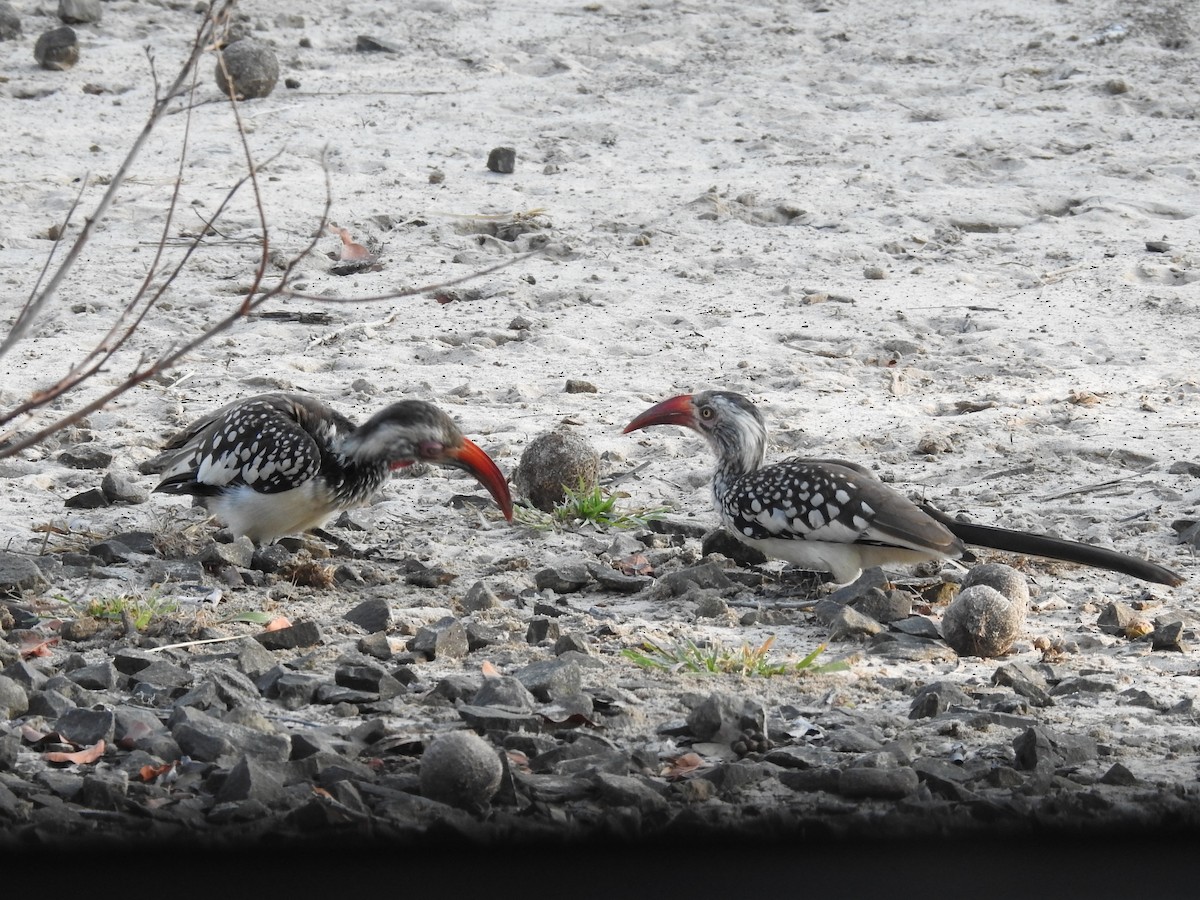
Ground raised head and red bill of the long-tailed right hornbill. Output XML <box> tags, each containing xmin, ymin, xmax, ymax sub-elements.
<box><xmin>623</xmin><ymin>391</ymin><xmax>767</xmax><ymax>472</ymax></box>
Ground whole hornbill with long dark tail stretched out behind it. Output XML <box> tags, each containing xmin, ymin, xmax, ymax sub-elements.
<box><xmin>625</xmin><ymin>391</ymin><xmax>1183</xmax><ymax>586</ymax></box>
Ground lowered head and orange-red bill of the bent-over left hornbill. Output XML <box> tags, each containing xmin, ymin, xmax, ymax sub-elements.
<box><xmin>343</xmin><ymin>400</ymin><xmax>512</xmax><ymax>522</ymax></box>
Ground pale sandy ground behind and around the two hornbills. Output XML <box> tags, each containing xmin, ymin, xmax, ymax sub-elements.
<box><xmin>0</xmin><ymin>0</ymin><xmax>1200</xmax><ymax>854</ymax></box>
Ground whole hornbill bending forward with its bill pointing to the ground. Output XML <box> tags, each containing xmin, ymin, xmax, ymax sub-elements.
<box><xmin>155</xmin><ymin>392</ymin><xmax>512</xmax><ymax>542</ymax></box>
